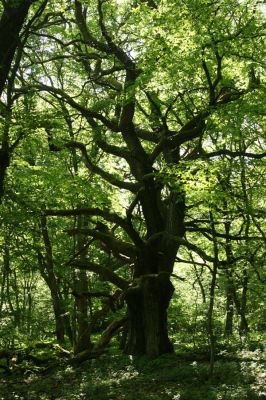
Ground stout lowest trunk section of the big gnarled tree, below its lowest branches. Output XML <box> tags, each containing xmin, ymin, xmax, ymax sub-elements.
<box><xmin>125</xmin><ymin>273</ymin><xmax>174</xmax><ymax>356</ymax></box>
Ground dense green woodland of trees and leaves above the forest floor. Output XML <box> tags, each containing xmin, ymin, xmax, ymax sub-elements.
<box><xmin>0</xmin><ymin>0</ymin><xmax>266</xmax><ymax>399</ymax></box>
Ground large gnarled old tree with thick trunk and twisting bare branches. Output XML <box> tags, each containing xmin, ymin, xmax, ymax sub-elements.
<box><xmin>3</xmin><ymin>0</ymin><xmax>265</xmax><ymax>355</ymax></box>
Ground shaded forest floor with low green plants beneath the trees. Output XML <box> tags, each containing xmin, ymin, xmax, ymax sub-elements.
<box><xmin>0</xmin><ymin>349</ymin><xmax>266</xmax><ymax>400</ymax></box>
